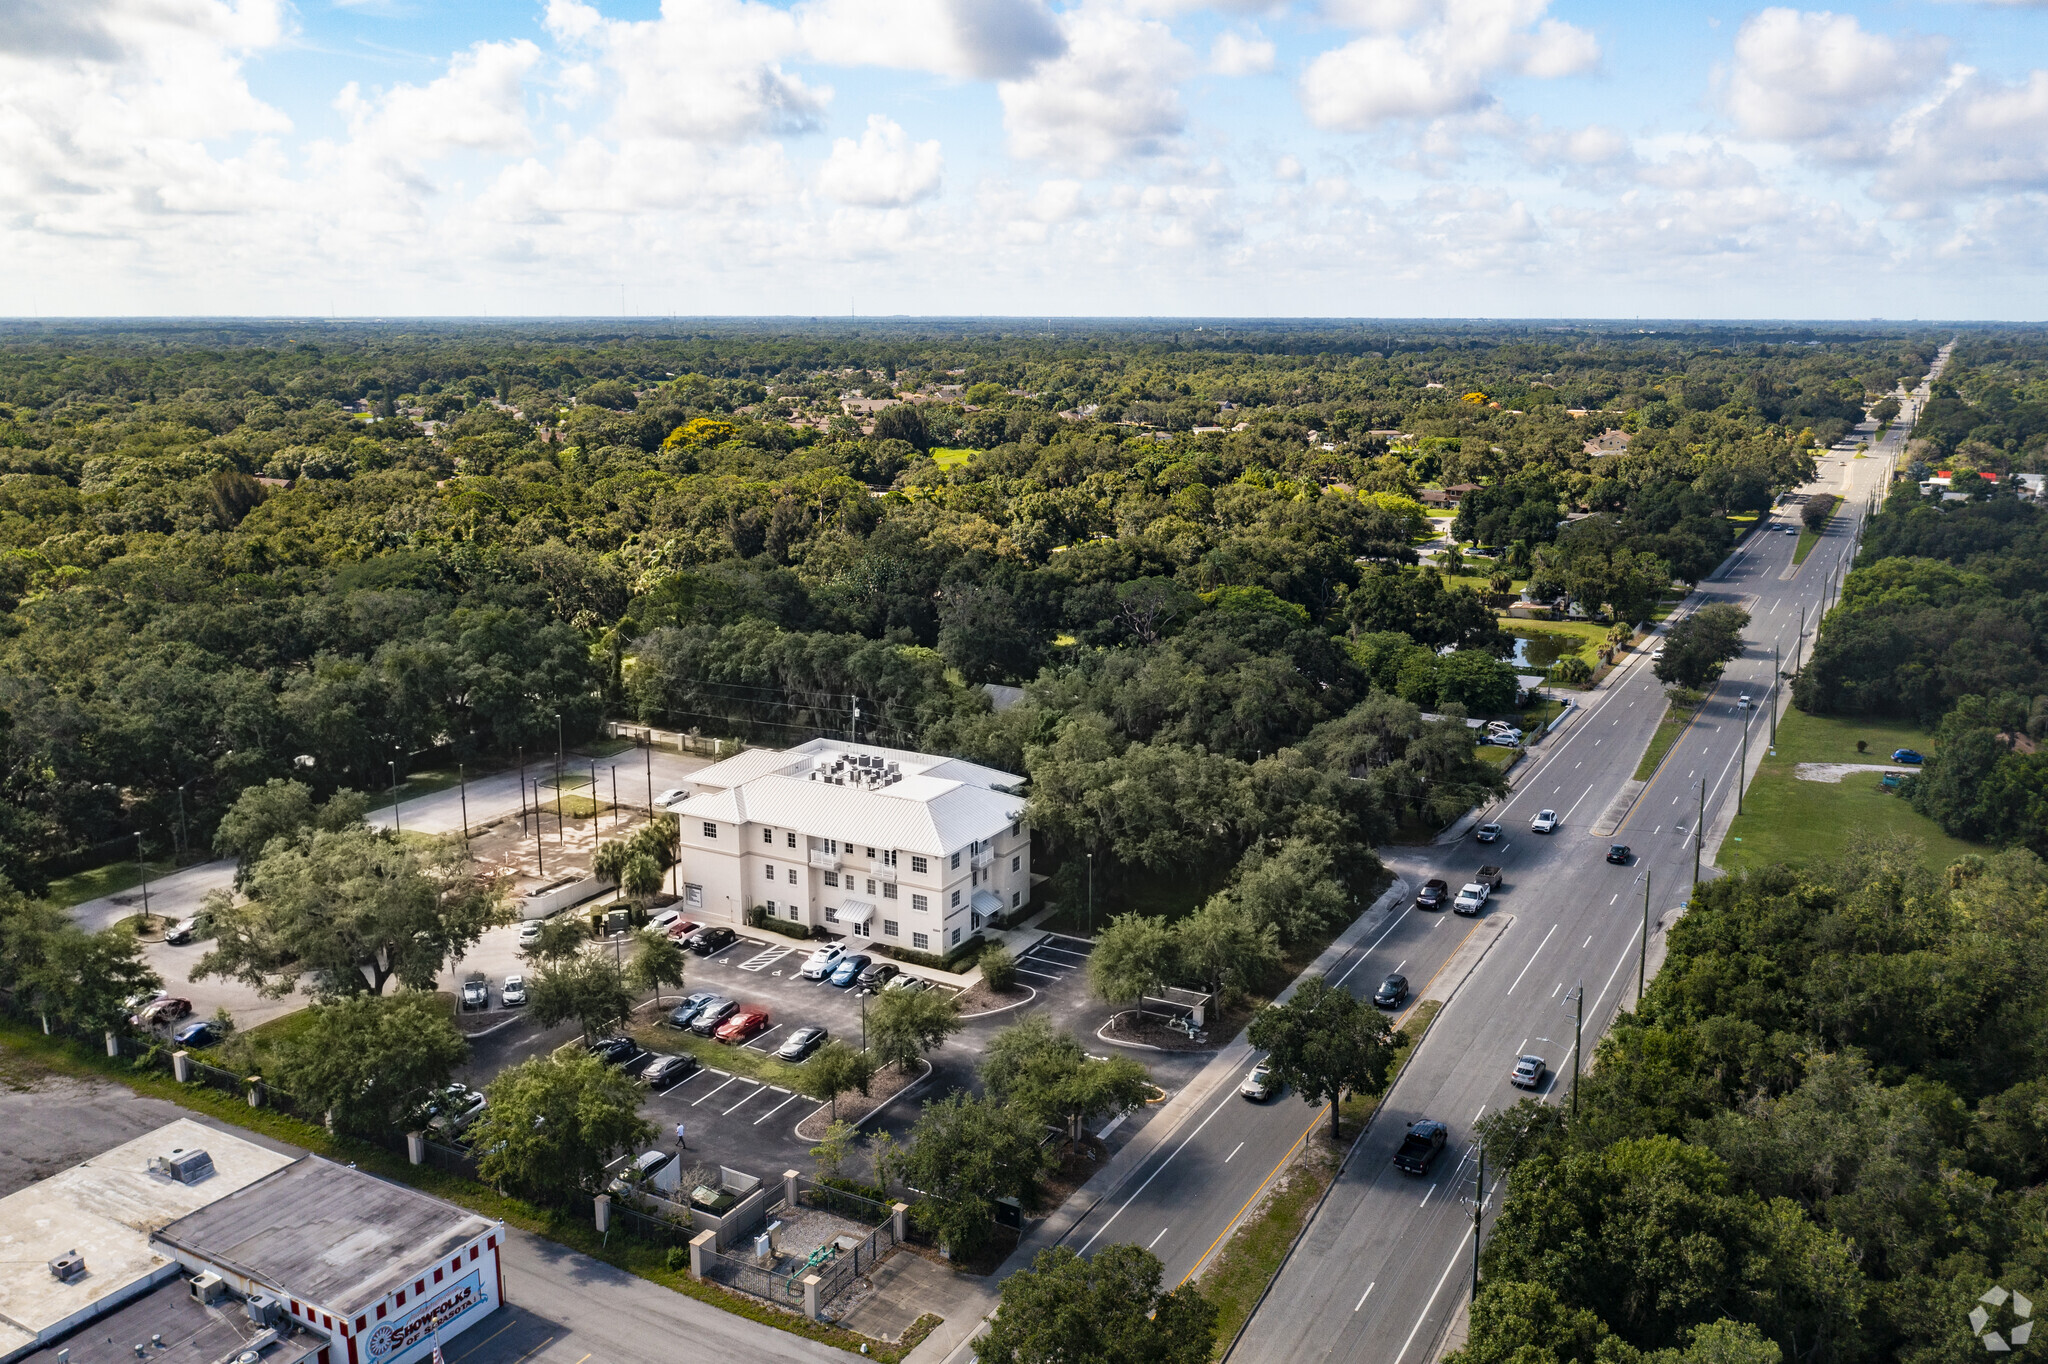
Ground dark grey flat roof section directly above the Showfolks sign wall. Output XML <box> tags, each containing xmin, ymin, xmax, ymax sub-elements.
<box><xmin>158</xmin><ymin>1155</ymin><xmax>494</xmax><ymax>1315</ymax></box>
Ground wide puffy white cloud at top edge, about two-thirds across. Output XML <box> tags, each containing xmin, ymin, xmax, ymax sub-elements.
<box><xmin>1300</xmin><ymin>0</ymin><xmax>1599</xmax><ymax>131</ymax></box>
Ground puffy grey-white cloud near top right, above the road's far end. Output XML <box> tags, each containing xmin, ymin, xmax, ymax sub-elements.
<box><xmin>1724</xmin><ymin>8</ymin><xmax>1944</xmax><ymax>160</ymax></box>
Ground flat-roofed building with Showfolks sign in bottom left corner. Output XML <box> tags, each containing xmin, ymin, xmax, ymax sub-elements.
<box><xmin>0</xmin><ymin>1122</ymin><xmax>504</xmax><ymax>1364</ymax></box>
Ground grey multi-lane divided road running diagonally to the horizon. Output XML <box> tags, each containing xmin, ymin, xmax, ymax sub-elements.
<box><xmin>1024</xmin><ymin>352</ymin><xmax>1946</xmax><ymax>1364</ymax></box>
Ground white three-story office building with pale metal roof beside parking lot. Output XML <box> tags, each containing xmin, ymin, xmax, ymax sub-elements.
<box><xmin>668</xmin><ymin>739</ymin><xmax>1030</xmax><ymax>952</ymax></box>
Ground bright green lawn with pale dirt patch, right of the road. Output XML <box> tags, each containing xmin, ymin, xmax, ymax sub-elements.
<box><xmin>1716</xmin><ymin>711</ymin><xmax>1987</xmax><ymax>872</ymax></box>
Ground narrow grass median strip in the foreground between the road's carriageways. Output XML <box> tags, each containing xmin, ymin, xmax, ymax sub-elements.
<box><xmin>1198</xmin><ymin>999</ymin><xmax>1444</xmax><ymax>1356</ymax></box>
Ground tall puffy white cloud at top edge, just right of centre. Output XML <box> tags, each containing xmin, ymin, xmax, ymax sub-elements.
<box><xmin>997</xmin><ymin>6</ymin><xmax>1192</xmax><ymax>174</ymax></box>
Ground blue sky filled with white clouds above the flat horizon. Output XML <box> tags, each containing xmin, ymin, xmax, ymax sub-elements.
<box><xmin>0</xmin><ymin>0</ymin><xmax>2048</xmax><ymax>319</ymax></box>
